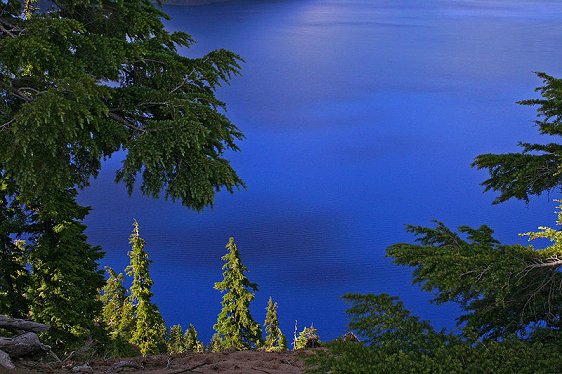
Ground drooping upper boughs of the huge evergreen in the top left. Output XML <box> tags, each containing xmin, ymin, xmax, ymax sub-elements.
<box><xmin>0</xmin><ymin>0</ymin><xmax>243</xmax><ymax>210</ymax></box>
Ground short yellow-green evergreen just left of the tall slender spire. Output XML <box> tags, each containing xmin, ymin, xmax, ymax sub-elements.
<box><xmin>100</xmin><ymin>266</ymin><xmax>136</xmax><ymax>356</ymax></box>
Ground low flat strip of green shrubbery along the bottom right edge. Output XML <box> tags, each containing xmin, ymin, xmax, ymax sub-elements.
<box><xmin>306</xmin><ymin>338</ymin><xmax>562</xmax><ymax>374</ymax></box>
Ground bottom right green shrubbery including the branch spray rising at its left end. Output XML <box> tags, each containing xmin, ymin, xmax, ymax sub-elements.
<box><xmin>307</xmin><ymin>294</ymin><xmax>562</xmax><ymax>374</ymax></box>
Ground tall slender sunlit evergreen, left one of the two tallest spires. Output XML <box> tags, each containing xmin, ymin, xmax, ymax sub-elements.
<box><xmin>126</xmin><ymin>221</ymin><xmax>166</xmax><ymax>356</ymax></box>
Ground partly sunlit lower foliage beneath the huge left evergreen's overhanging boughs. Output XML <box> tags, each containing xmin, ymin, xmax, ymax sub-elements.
<box><xmin>29</xmin><ymin>192</ymin><xmax>104</xmax><ymax>350</ymax></box>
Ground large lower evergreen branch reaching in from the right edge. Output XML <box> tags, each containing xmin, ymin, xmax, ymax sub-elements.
<box><xmin>388</xmin><ymin>213</ymin><xmax>562</xmax><ymax>339</ymax></box>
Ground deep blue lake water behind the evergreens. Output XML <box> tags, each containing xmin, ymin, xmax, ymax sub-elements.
<box><xmin>81</xmin><ymin>0</ymin><xmax>562</xmax><ymax>341</ymax></box>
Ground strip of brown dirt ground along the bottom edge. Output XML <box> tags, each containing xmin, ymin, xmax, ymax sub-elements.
<box><xmin>4</xmin><ymin>350</ymin><xmax>313</xmax><ymax>374</ymax></box>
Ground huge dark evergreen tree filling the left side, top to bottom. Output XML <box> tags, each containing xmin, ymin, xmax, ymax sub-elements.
<box><xmin>0</xmin><ymin>0</ymin><xmax>244</xmax><ymax>347</ymax></box>
